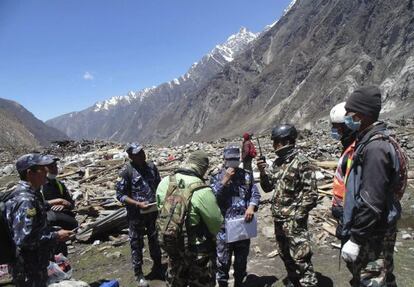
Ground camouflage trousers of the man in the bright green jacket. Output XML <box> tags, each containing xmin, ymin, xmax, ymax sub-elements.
<box><xmin>166</xmin><ymin>252</ymin><xmax>216</xmax><ymax>287</ymax></box>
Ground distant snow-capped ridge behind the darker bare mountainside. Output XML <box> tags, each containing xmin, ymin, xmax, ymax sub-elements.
<box><xmin>47</xmin><ymin>27</ymin><xmax>257</xmax><ymax>141</ymax></box>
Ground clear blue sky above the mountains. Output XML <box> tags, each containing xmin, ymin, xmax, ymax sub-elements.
<box><xmin>0</xmin><ymin>0</ymin><xmax>290</xmax><ymax>120</ymax></box>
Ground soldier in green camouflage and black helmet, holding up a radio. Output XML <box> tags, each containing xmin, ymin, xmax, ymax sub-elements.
<box><xmin>257</xmin><ymin>125</ymin><xmax>318</xmax><ymax>286</ymax></box>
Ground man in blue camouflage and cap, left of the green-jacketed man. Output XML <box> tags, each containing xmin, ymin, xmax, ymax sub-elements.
<box><xmin>116</xmin><ymin>143</ymin><xmax>163</xmax><ymax>286</ymax></box>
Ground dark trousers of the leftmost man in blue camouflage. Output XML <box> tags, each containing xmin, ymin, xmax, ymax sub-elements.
<box><xmin>9</xmin><ymin>251</ymin><xmax>49</xmax><ymax>287</ymax></box>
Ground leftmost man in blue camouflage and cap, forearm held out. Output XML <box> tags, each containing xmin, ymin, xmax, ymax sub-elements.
<box><xmin>5</xmin><ymin>154</ymin><xmax>73</xmax><ymax>287</ymax></box>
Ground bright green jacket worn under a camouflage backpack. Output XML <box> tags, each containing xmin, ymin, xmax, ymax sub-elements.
<box><xmin>156</xmin><ymin>173</ymin><xmax>223</xmax><ymax>245</ymax></box>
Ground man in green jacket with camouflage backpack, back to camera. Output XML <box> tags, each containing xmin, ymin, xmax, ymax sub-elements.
<box><xmin>157</xmin><ymin>151</ymin><xmax>223</xmax><ymax>287</ymax></box>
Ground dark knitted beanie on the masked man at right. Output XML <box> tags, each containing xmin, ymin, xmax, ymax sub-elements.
<box><xmin>345</xmin><ymin>86</ymin><xmax>381</xmax><ymax>120</ymax></box>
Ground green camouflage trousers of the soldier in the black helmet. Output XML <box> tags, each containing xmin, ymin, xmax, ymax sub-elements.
<box><xmin>275</xmin><ymin>219</ymin><xmax>318</xmax><ymax>287</ymax></box>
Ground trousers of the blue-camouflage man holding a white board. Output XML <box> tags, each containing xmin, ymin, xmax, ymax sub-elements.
<box><xmin>216</xmin><ymin>228</ymin><xmax>250</xmax><ymax>284</ymax></box>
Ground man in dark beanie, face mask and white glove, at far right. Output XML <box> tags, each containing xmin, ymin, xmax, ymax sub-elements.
<box><xmin>342</xmin><ymin>86</ymin><xmax>406</xmax><ymax>286</ymax></box>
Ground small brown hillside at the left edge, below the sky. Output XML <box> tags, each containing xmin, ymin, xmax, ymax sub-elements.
<box><xmin>0</xmin><ymin>99</ymin><xmax>68</xmax><ymax>151</ymax></box>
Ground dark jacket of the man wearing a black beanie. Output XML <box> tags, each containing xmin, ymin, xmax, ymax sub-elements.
<box><xmin>343</xmin><ymin>122</ymin><xmax>401</xmax><ymax>244</ymax></box>
